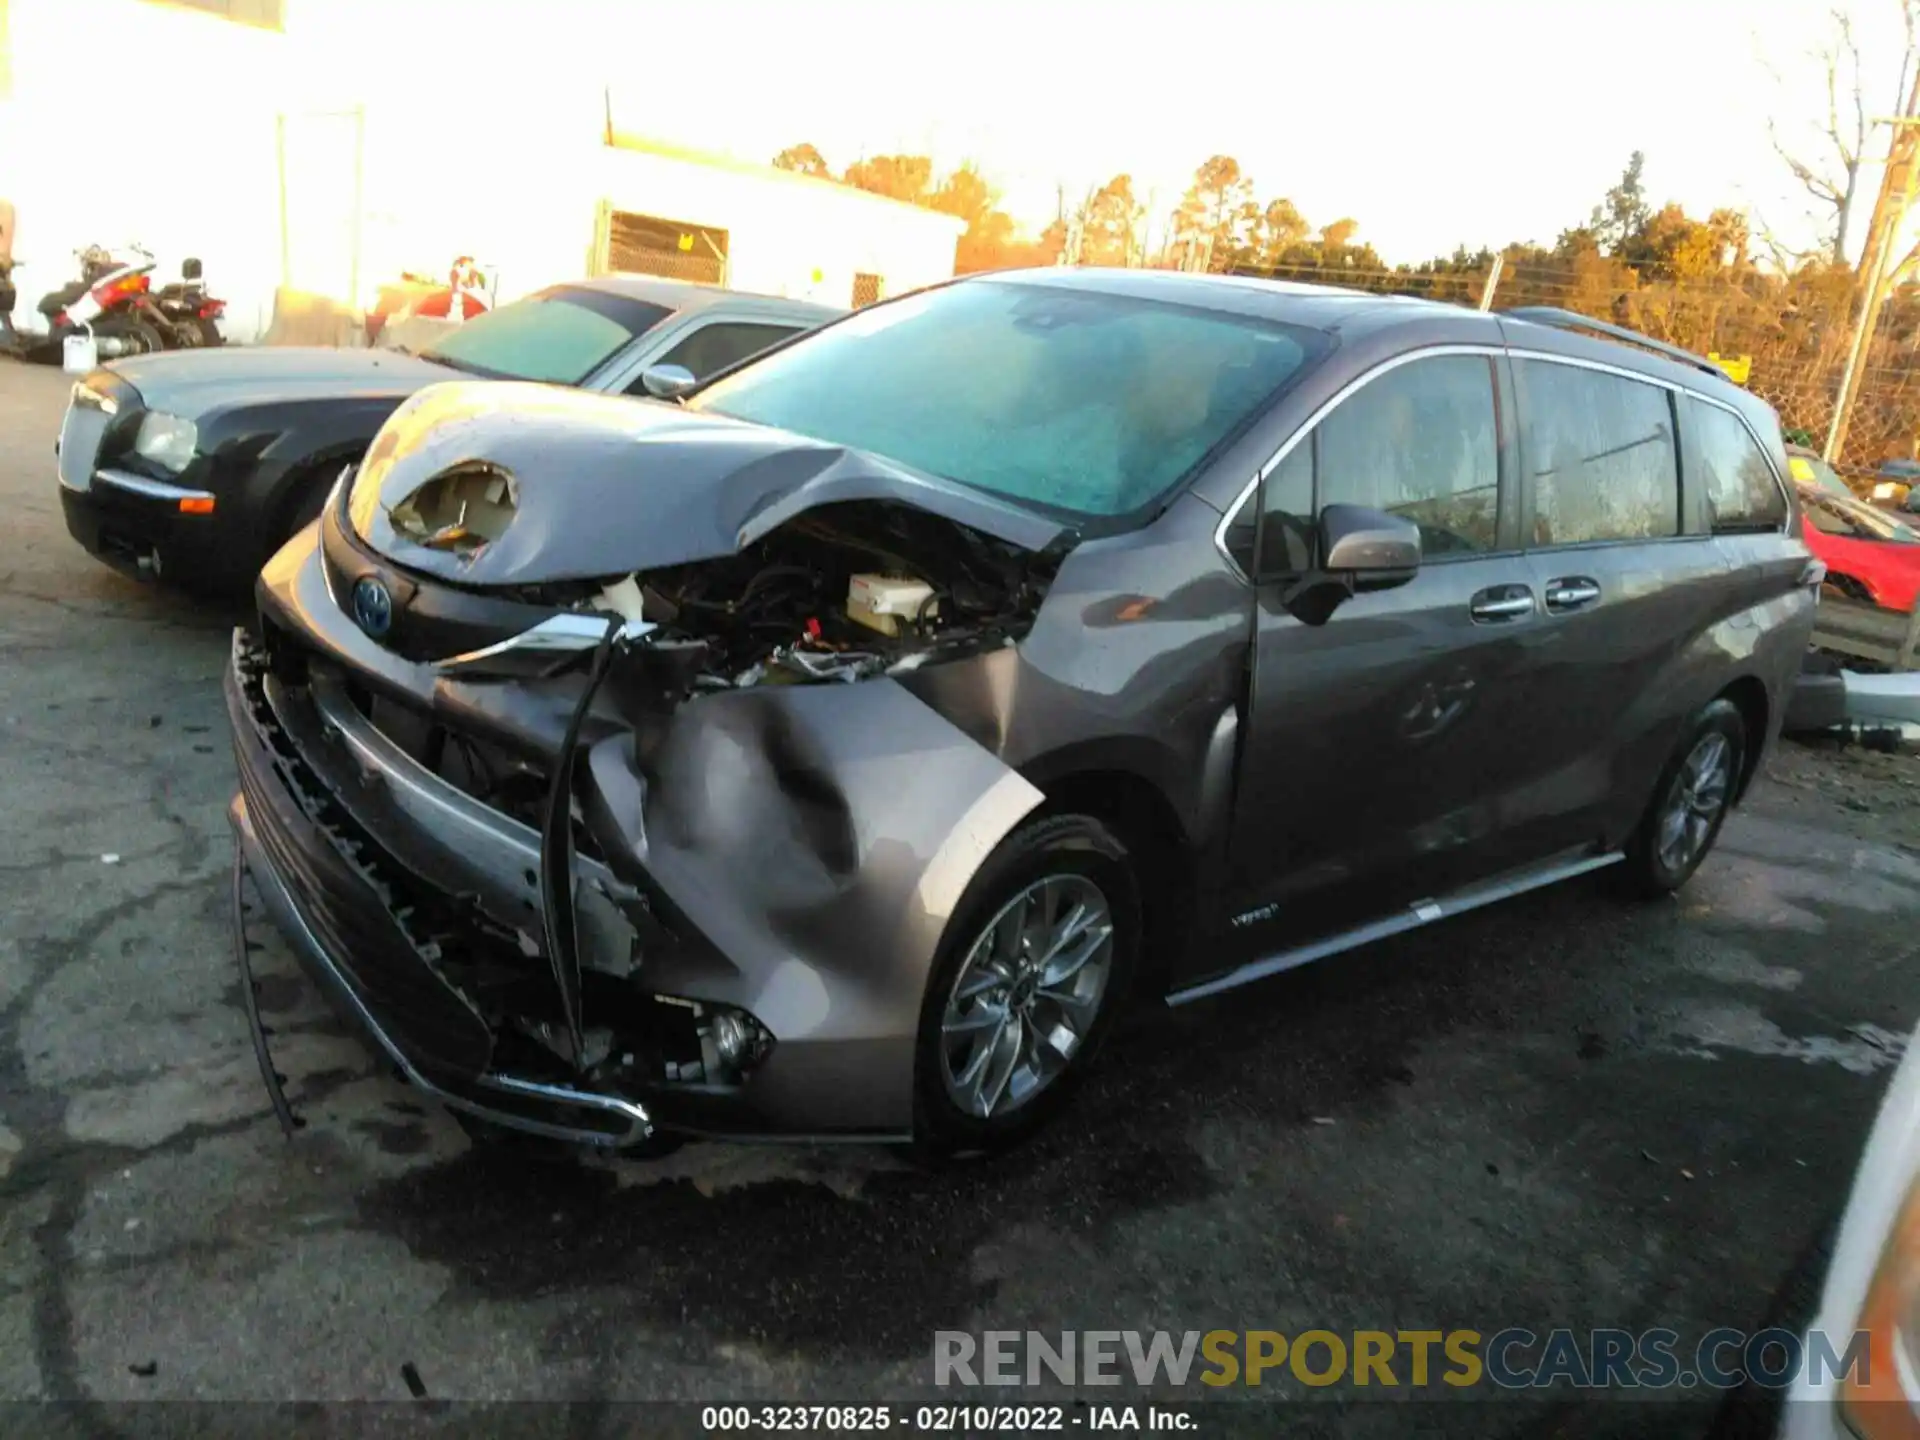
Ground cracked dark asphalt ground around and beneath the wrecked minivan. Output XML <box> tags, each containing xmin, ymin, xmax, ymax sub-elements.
<box><xmin>0</xmin><ymin>353</ymin><xmax>1920</xmax><ymax>1436</ymax></box>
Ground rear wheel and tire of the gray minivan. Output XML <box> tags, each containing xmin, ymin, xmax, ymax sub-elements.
<box><xmin>1622</xmin><ymin>699</ymin><xmax>1747</xmax><ymax>899</ymax></box>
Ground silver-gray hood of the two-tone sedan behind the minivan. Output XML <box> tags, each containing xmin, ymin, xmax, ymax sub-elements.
<box><xmin>108</xmin><ymin>346</ymin><xmax>455</xmax><ymax>419</ymax></box>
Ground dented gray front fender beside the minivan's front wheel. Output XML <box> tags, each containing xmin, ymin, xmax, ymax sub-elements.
<box><xmin>580</xmin><ymin>680</ymin><xmax>1044</xmax><ymax>1133</ymax></box>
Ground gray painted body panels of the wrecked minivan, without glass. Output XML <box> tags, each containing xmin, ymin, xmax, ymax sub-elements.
<box><xmin>232</xmin><ymin>273</ymin><xmax>1814</xmax><ymax>1131</ymax></box>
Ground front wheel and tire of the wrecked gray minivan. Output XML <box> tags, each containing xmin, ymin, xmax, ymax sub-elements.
<box><xmin>914</xmin><ymin>814</ymin><xmax>1140</xmax><ymax>1156</ymax></box>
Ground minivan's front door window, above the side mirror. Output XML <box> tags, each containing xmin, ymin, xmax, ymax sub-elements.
<box><xmin>1315</xmin><ymin>355</ymin><xmax>1500</xmax><ymax>555</ymax></box>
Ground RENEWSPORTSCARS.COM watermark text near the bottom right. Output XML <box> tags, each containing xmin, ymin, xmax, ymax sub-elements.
<box><xmin>933</xmin><ymin>1327</ymin><xmax>1870</xmax><ymax>1390</ymax></box>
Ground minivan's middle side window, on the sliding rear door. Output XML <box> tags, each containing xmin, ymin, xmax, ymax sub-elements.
<box><xmin>1513</xmin><ymin>359</ymin><xmax>1680</xmax><ymax>545</ymax></box>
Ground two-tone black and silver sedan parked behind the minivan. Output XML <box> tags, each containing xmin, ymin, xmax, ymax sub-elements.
<box><xmin>58</xmin><ymin>276</ymin><xmax>841</xmax><ymax>593</ymax></box>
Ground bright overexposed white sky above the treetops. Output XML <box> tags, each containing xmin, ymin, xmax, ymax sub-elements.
<box><xmin>591</xmin><ymin>0</ymin><xmax>1901</xmax><ymax>259</ymax></box>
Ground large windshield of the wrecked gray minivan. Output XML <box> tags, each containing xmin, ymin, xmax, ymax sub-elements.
<box><xmin>689</xmin><ymin>280</ymin><xmax>1321</xmax><ymax>518</ymax></box>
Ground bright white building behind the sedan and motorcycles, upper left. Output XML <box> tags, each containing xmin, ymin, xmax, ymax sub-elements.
<box><xmin>0</xmin><ymin>0</ymin><xmax>962</xmax><ymax>338</ymax></box>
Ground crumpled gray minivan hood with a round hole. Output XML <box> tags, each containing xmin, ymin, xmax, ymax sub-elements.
<box><xmin>349</xmin><ymin>380</ymin><xmax>1062</xmax><ymax>586</ymax></box>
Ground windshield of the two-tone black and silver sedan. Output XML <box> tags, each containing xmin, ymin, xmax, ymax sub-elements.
<box><xmin>420</xmin><ymin>286</ymin><xmax>670</xmax><ymax>386</ymax></box>
